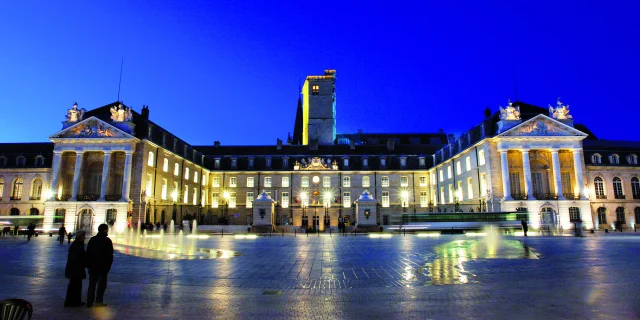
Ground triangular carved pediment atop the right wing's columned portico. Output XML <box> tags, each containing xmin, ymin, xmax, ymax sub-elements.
<box><xmin>498</xmin><ymin>114</ymin><xmax>587</xmax><ymax>138</ymax></box>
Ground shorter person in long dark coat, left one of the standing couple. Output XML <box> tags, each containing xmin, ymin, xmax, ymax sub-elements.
<box><xmin>60</xmin><ymin>230</ymin><xmax>87</xmax><ymax>307</ymax></box>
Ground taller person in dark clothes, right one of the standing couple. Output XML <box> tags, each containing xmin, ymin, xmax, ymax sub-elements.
<box><xmin>85</xmin><ymin>223</ymin><xmax>113</xmax><ymax>307</ymax></box>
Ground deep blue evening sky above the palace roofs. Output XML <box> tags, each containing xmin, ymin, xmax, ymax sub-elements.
<box><xmin>0</xmin><ymin>1</ymin><xmax>640</xmax><ymax>145</ymax></box>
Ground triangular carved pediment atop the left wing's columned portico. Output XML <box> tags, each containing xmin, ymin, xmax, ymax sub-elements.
<box><xmin>49</xmin><ymin>117</ymin><xmax>135</xmax><ymax>140</ymax></box>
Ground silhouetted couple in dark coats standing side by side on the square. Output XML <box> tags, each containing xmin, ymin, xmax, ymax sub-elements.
<box><xmin>64</xmin><ymin>224</ymin><xmax>113</xmax><ymax>307</ymax></box>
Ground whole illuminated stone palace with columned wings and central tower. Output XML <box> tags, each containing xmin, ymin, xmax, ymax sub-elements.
<box><xmin>0</xmin><ymin>70</ymin><xmax>640</xmax><ymax>232</ymax></box>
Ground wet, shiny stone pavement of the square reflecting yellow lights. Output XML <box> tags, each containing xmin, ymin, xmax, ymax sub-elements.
<box><xmin>0</xmin><ymin>233</ymin><xmax>640</xmax><ymax>319</ymax></box>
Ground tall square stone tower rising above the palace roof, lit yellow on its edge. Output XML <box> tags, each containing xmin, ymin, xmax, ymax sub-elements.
<box><xmin>302</xmin><ymin>70</ymin><xmax>336</xmax><ymax>145</ymax></box>
